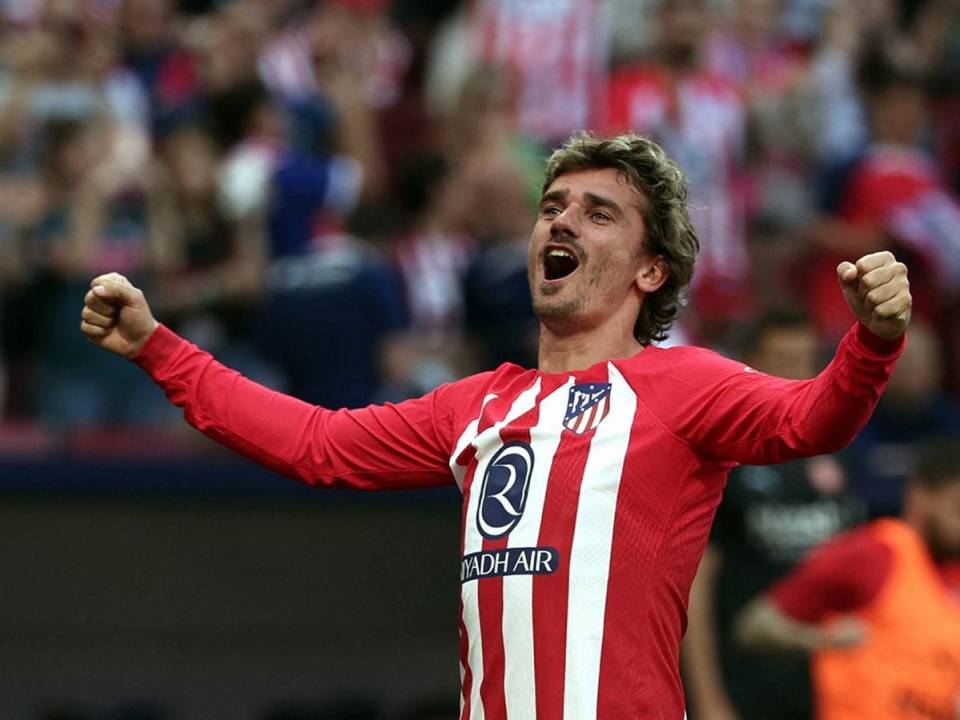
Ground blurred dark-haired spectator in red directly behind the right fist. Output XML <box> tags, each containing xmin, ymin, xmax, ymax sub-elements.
<box><xmin>807</xmin><ymin>49</ymin><xmax>960</xmax><ymax>339</ymax></box>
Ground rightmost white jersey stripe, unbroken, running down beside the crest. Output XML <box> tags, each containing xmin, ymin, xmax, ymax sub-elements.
<box><xmin>563</xmin><ymin>363</ymin><xmax>637</xmax><ymax>720</ymax></box>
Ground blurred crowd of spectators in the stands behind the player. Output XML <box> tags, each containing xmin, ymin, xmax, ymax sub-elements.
<box><xmin>0</xmin><ymin>0</ymin><xmax>960</xmax><ymax>717</ymax></box>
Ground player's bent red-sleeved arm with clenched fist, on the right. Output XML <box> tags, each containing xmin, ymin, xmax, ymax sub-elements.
<box><xmin>662</xmin><ymin>252</ymin><xmax>911</xmax><ymax>465</ymax></box>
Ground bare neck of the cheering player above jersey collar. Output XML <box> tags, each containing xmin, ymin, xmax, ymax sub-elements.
<box><xmin>537</xmin><ymin>323</ymin><xmax>643</xmax><ymax>372</ymax></box>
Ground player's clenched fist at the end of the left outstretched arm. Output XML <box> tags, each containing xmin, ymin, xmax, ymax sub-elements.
<box><xmin>80</xmin><ymin>273</ymin><xmax>159</xmax><ymax>358</ymax></box>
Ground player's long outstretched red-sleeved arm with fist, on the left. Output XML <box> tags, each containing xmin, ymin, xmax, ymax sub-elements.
<box><xmin>81</xmin><ymin>273</ymin><xmax>469</xmax><ymax>489</ymax></box>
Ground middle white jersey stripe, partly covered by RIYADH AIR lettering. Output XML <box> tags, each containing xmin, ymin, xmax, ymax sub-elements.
<box><xmin>503</xmin><ymin>377</ymin><xmax>573</xmax><ymax>720</ymax></box>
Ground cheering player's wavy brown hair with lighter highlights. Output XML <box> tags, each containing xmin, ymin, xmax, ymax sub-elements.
<box><xmin>543</xmin><ymin>132</ymin><xmax>700</xmax><ymax>345</ymax></box>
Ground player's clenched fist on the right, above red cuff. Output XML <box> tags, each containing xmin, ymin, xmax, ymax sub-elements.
<box><xmin>837</xmin><ymin>250</ymin><xmax>913</xmax><ymax>340</ymax></box>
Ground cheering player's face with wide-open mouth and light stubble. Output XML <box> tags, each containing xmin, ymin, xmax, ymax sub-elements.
<box><xmin>527</xmin><ymin>169</ymin><xmax>652</xmax><ymax>334</ymax></box>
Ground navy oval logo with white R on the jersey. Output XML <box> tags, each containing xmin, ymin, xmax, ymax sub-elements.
<box><xmin>477</xmin><ymin>441</ymin><xmax>533</xmax><ymax>540</ymax></box>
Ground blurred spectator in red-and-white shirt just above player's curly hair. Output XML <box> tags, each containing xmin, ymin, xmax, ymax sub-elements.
<box><xmin>595</xmin><ymin>0</ymin><xmax>752</xmax><ymax>342</ymax></box>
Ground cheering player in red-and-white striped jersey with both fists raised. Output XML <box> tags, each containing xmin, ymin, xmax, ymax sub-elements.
<box><xmin>81</xmin><ymin>135</ymin><xmax>911</xmax><ymax>720</ymax></box>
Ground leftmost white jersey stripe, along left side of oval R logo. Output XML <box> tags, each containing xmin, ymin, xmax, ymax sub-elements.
<box><xmin>460</xmin><ymin>378</ymin><xmax>540</xmax><ymax>720</ymax></box>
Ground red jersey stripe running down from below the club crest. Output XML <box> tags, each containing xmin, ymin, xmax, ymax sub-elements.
<box><xmin>533</xmin><ymin>420</ymin><xmax>593</xmax><ymax>718</ymax></box>
